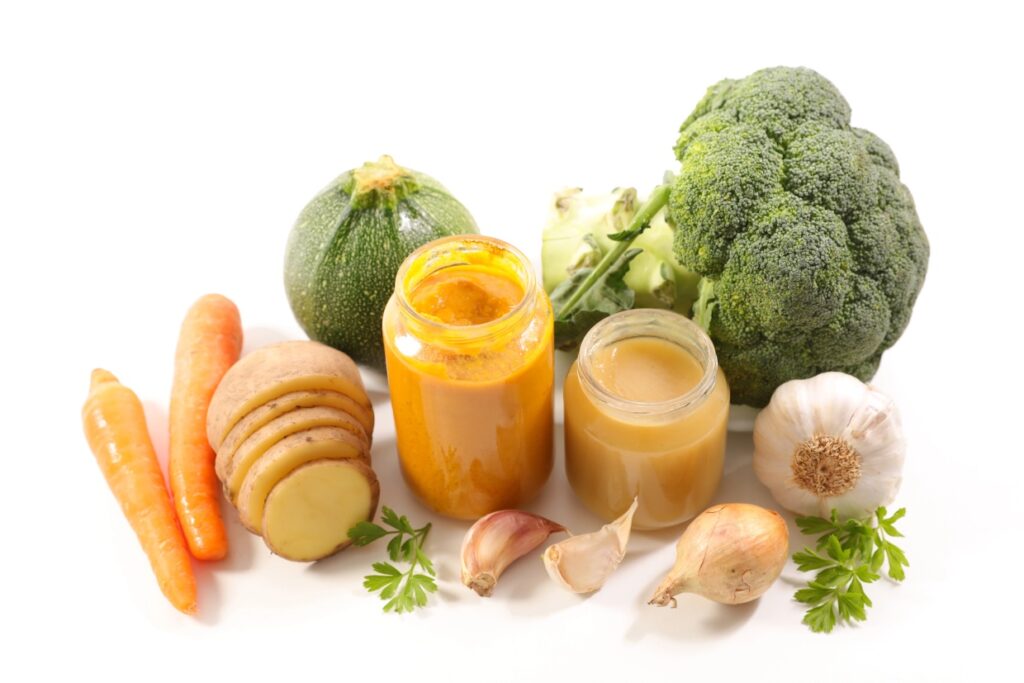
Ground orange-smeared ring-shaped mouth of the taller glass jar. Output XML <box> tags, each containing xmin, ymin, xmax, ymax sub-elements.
<box><xmin>394</xmin><ymin>234</ymin><xmax>537</xmax><ymax>343</ymax></box>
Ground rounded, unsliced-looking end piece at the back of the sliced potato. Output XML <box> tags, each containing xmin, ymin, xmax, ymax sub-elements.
<box><xmin>207</xmin><ymin>341</ymin><xmax>373</xmax><ymax>451</ymax></box>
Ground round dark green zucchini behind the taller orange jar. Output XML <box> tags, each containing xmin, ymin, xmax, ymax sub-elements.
<box><xmin>285</xmin><ymin>156</ymin><xmax>477</xmax><ymax>370</ymax></box>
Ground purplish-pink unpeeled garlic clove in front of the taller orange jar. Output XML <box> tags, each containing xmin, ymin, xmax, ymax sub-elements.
<box><xmin>462</xmin><ymin>510</ymin><xmax>566</xmax><ymax>598</ymax></box>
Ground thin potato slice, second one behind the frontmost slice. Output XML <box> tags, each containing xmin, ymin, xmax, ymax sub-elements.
<box><xmin>223</xmin><ymin>407</ymin><xmax>370</xmax><ymax>503</ymax></box>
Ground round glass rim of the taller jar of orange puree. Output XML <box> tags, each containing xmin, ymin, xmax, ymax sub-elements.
<box><xmin>394</xmin><ymin>234</ymin><xmax>537</xmax><ymax>342</ymax></box>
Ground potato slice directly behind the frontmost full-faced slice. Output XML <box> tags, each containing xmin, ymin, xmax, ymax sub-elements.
<box><xmin>236</xmin><ymin>427</ymin><xmax>370</xmax><ymax>533</ymax></box>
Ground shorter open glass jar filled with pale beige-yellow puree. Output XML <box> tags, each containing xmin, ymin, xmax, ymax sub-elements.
<box><xmin>564</xmin><ymin>309</ymin><xmax>729</xmax><ymax>529</ymax></box>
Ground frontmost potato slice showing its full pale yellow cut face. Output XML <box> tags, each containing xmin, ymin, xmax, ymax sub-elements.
<box><xmin>262</xmin><ymin>459</ymin><xmax>380</xmax><ymax>562</ymax></box>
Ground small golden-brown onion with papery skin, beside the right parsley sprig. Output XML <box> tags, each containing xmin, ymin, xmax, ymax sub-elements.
<box><xmin>648</xmin><ymin>503</ymin><xmax>790</xmax><ymax>607</ymax></box>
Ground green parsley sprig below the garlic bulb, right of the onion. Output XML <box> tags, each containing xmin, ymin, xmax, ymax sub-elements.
<box><xmin>793</xmin><ymin>507</ymin><xmax>909</xmax><ymax>633</ymax></box>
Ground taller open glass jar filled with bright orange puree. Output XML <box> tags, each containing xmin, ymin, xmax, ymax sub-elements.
<box><xmin>383</xmin><ymin>234</ymin><xmax>554</xmax><ymax>519</ymax></box>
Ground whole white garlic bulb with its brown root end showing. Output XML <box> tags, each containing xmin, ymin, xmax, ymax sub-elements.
<box><xmin>754</xmin><ymin>373</ymin><xmax>906</xmax><ymax>518</ymax></box>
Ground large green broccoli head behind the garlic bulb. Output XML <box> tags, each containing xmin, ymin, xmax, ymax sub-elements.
<box><xmin>668</xmin><ymin>68</ymin><xmax>929</xmax><ymax>407</ymax></box>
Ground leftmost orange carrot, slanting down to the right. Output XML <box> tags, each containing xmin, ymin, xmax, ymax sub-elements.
<box><xmin>82</xmin><ymin>370</ymin><xmax>196</xmax><ymax>614</ymax></box>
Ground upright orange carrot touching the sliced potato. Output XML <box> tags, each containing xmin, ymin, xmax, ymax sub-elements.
<box><xmin>168</xmin><ymin>294</ymin><xmax>242</xmax><ymax>560</ymax></box>
